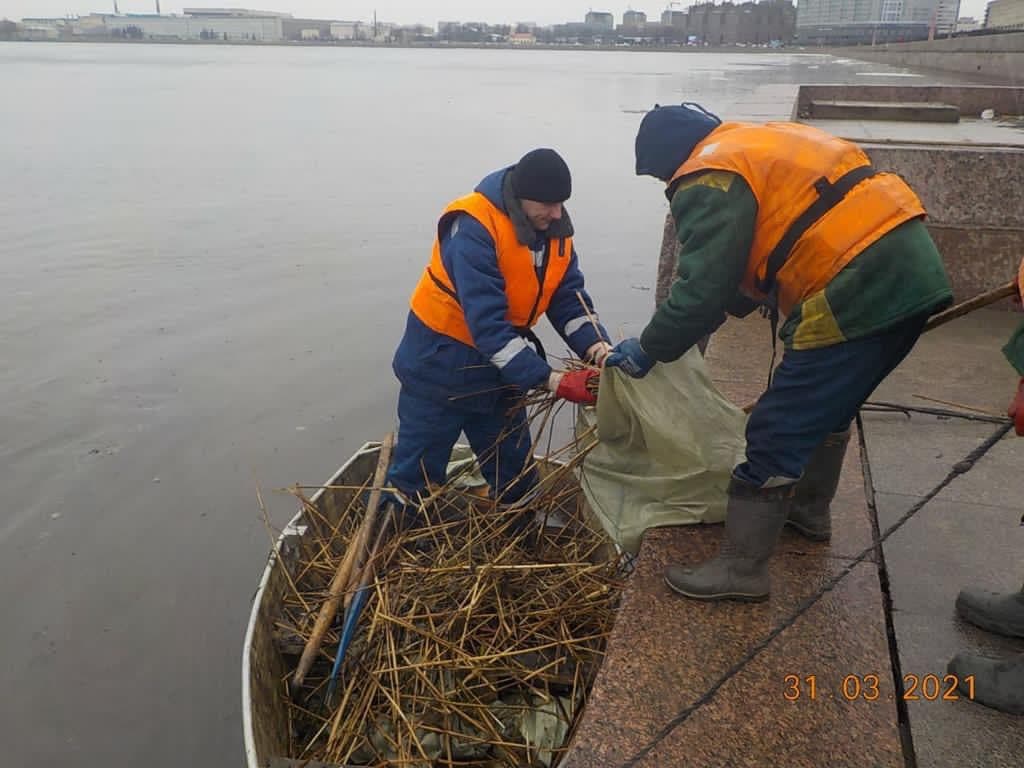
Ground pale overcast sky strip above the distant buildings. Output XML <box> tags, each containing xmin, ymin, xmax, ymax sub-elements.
<box><xmin>0</xmin><ymin>0</ymin><xmax>986</xmax><ymax>26</ymax></box>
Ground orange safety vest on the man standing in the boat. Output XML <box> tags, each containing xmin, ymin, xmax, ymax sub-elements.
<box><xmin>410</xmin><ymin>193</ymin><xmax>572</xmax><ymax>346</ymax></box>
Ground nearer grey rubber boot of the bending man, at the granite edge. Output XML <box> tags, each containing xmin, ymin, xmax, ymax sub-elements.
<box><xmin>665</xmin><ymin>477</ymin><xmax>794</xmax><ymax>601</ymax></box>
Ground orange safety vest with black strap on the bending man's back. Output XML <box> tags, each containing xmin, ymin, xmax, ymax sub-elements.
<box><xmin>669</xmin><ymin>123</ymin><xmax>925</xmax><ymax>314</ymax></box>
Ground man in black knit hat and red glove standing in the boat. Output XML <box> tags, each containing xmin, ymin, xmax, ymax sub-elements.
<box><xmin>388</xmin><ymin>148</ymin><xmax>611</xmax><ymax>514</ymax></box>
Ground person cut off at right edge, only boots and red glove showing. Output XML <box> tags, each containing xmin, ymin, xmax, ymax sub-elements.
<box><xmin>948</xmin><ymin>259</ymin><xmax>1024</xmax><ymax>715</ymax></box>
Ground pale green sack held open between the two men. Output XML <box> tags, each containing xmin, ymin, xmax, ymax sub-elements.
<box><xmin>578</xmin><ymin>347</ymin><xmax>746</xmax><ymax>554</ymax></box>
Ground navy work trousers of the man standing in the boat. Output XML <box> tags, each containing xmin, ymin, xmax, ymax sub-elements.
<box><xmin>387</xmin><ymin>386</ymin><xmax>537</xmax><ymax>504</ymax></box>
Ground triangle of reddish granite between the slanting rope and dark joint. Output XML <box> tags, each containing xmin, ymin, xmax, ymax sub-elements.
<box><xmin>637</xmin><ymin>563</ymin><xmax>904</xmax><ymax>768</ymax></box>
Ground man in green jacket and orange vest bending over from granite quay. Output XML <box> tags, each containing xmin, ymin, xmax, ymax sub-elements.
<box><xmin>606</xmin><ymin>104</ymin><xmax>952</xmax><ymax>600</ymax></box>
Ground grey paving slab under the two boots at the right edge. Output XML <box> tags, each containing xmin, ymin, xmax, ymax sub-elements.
<box><xmin>884</xmin><ymin>499</ymin><xmax>1024</xmax><ymax>768</ymax></box>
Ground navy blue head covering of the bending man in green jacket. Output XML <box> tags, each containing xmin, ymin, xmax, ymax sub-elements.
<box><xmin>636</xmin><ymin>101</ymin><xmax>722</xmax><ymax>181</ymax></box>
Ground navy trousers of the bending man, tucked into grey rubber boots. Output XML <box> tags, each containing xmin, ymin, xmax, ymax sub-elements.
<box><xmin>733</xmin><ymin>315</ymin><xmax>928</xmax><ymax>487</ymax></box>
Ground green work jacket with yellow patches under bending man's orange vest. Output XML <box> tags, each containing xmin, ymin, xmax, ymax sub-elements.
<box><xmin>640</xmin><ymin>170</ymin><xmax>954</xmax><ymax>362</ymax></box>
